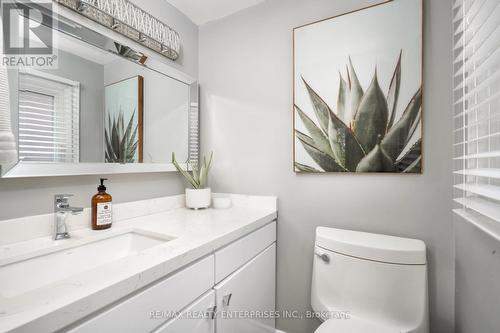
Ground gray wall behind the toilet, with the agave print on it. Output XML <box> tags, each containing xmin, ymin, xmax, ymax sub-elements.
<box><xmin>199</xmin><ymin>0</ymin><xmax>454</xmax><ymax>333</ymax></box>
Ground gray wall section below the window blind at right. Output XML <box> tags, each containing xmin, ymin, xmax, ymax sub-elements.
<box><xmin>455</xmin><ymin>216</ymin><xmax>500</xmax><ymax>333</ymax></box>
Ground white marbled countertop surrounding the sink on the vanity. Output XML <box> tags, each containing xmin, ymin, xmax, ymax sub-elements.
<box><xmin>0</xmin><ymin>196</ymin><xmax>277</xmax><ymax>333</ymax></box>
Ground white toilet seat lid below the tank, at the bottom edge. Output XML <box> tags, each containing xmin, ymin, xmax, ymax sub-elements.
<box><xmin>315</xmin><ymin>318</ymin><xmax>401</xmax><ymax>333</ymax></box>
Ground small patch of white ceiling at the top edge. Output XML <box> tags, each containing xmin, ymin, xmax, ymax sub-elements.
<box><xmin>167</xmin><ymin>0</ymin><xmax>264</xmax><ymax>25</ymax></box>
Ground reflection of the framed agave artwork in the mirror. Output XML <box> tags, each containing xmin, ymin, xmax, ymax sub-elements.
<box><xmin>104</xmin><ymin>76</ymin><xmax>144</xmax><ymax>163</ymax></box>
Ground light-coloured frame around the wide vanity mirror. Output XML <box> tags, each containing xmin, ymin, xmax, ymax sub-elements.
<box><xmin>0</xmin><ymin>2</ymin><xmax>200</xmax><ymax>178</ymax></box>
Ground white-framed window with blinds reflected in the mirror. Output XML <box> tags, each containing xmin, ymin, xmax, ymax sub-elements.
<box><xmin>18</xmin><ymin>70</ymin><xmax>80</xmax><ymax>163</ymax></box>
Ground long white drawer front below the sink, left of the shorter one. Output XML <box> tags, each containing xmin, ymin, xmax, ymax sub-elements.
<box><xmin>69</xmin><ymin>256</ymin><xmax>214</xmax><ymax>333</ymax></box>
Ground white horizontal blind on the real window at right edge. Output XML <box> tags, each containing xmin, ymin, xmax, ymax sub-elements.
<box><xmin>453</xmin><ymin>0</ymin><xmax>500</xmax><ymax>223</ymax></box>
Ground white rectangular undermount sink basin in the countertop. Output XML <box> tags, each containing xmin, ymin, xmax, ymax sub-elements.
<box><xmin>0</xmin><ymin>230</ymin><xmax>173</xmax><ymax>297</ymax></box>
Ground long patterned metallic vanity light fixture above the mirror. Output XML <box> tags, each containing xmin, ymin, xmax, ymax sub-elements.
<box><xmin>56</xmin><ymin>0</ymin><xmax>181</xmax><ymax>60</ymax></box>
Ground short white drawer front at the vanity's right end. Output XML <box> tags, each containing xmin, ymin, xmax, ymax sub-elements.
<box><xmin>215</xmin><ymin>222</ymin><xmax>276</xmax><ymax>283</ymax></box>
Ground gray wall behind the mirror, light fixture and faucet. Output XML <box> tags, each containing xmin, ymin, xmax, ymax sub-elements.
<box><xmin>0</xmin><ymin>0</ymin><xmax>198</xmax><ymax>220</ymax></box>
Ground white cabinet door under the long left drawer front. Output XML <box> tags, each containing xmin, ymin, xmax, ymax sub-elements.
<box><xmin>154</xmin><ymin>290</ymin><xmax>215</xmax><ymax>333</ymax></box>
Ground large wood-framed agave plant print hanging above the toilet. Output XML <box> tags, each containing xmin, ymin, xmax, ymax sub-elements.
<box><xmin>294</xmin><ymin>0</ymin><xmax>422</xmax><ymax>173</ymax></box>
